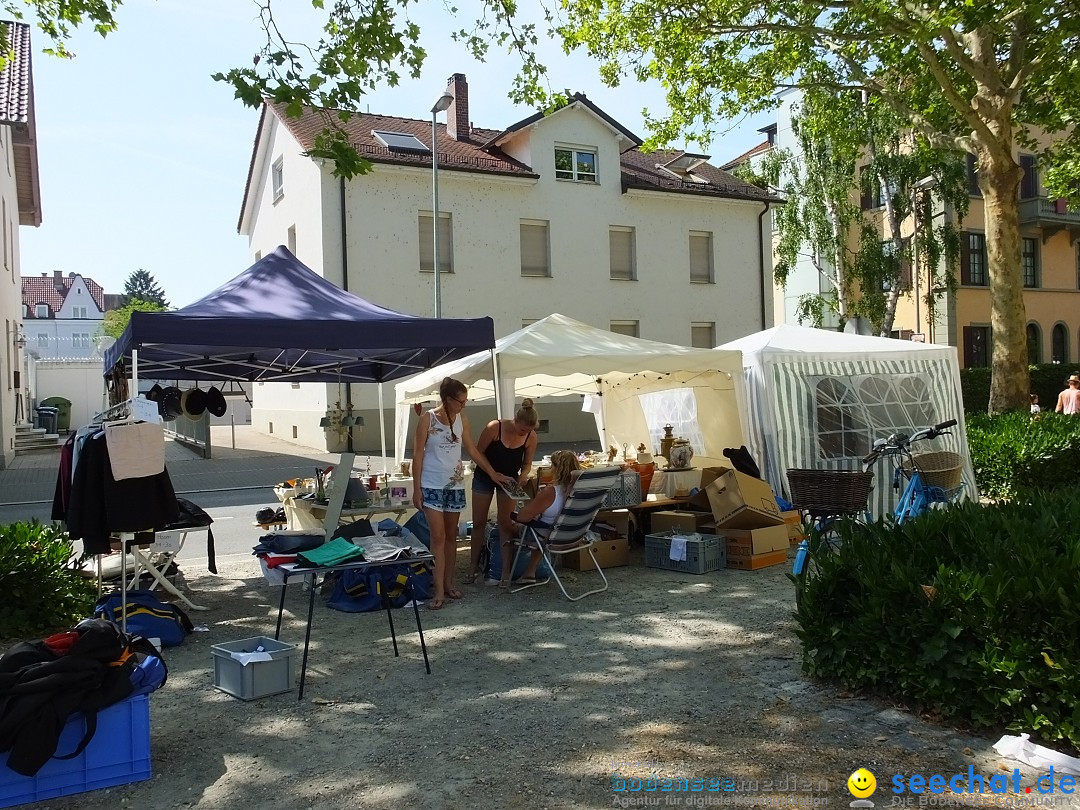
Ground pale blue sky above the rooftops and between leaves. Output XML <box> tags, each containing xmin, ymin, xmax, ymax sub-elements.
<box><xmin>19</xmin><ymin>0</ymin><xmax>768</xmax><ymax>307</ymax></box>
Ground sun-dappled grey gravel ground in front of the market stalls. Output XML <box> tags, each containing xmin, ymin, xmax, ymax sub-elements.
<box><xmin>27</xmin><ymin>546</ymin><xmax>1072</xmax><ymax>810</ymax></box>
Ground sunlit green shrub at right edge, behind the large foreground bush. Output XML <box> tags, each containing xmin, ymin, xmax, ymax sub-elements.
<box><xmin>968</xmin><ymin>414</ymin><xmax>1080</xmax><ymax>499</ymax></box>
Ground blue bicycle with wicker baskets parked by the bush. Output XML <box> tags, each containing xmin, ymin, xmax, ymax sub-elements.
<box><xmin>787</xmin><ymin>419</ymin><xmax>963</xmax><ymax>609</ymax></box>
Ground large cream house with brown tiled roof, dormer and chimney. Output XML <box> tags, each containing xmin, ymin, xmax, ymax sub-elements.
<box><xmin>238</xmin><ymin>73</ymin><xmax>773</xmax><ymax>446</ymax></box>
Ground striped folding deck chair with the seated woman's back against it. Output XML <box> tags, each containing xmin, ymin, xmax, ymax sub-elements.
<box><xmin>510</xmin><ymin>467</ymin><xmax>620</xmax><ymax>602</ymax></box>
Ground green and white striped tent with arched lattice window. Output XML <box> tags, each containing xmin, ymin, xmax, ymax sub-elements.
<box><xmin>717</xmin><ymin>324</ymin><xmax>977</xmax><ymax>516</ymax></box>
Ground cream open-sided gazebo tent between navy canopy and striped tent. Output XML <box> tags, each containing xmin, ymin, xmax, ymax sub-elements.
<box><xmin>394</xmin><ymin>314</ymin><xmax>747</xmax><ymax>467</ymax></box>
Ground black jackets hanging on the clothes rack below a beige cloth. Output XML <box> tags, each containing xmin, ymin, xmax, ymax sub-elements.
<box><xmin>53</xmin><ymin>434</ymin><xmax>179</xmax><ymax>554</ymax></box>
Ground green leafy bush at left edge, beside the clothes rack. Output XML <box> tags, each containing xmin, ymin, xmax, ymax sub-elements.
<box><xmin>0</xmin><ymin>521</ymin><xmax>97</xmax><ymax>639</ymax></box>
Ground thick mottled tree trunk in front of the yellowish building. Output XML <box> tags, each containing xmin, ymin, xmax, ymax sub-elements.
<box><xmin>978</xmin><ymin>147</ymin><xmax>1028</xmax><ymax>414</ymax></box>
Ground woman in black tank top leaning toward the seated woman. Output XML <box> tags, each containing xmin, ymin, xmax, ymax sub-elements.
<box><xmin>464</xmin><ymin>400</ymin><xmax>539</xmax><ymax>584</ymax></box>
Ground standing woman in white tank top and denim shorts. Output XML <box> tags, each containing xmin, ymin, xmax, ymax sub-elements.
<box><xmin>413</xmin><ymin>377</ymin><xmax>509</xmax><ymax>610</ymax></box>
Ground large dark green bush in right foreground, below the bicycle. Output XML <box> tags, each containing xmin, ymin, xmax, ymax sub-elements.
<box><xmin>797</xmin><ymin>492</ymin><xmax>1080</xmax><ymax>760</ymax></box>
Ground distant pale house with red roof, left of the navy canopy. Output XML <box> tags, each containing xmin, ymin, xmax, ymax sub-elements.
<box><xmin>23</xmin><ymin>270</ymin><xmax>105</xmax><ymax>360</ymax></box>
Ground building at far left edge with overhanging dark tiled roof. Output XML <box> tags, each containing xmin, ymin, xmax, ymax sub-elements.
<box><xmin>0</xmin><ymin>23</ymin><xmax>41</xmax><ymax>469</ymax></box>
